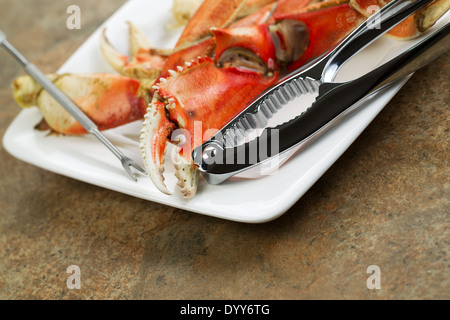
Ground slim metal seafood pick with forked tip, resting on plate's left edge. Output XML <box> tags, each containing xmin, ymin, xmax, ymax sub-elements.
<box><xmin>0</xmin><ymin>30</ymin><xmax>147</xmax><ymax>181</ymax></box>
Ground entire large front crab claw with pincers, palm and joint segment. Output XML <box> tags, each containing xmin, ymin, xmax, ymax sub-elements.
<box><xmin>141</xmin><ymin>27</ymin><xmax>279</xmax><ymax>198</ymax></box>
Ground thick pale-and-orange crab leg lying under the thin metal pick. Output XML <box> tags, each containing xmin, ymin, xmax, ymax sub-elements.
<box><xmin>13</xmin><ymin>74</ymin><xmax>149</xmax><ymax>135</ymax></box>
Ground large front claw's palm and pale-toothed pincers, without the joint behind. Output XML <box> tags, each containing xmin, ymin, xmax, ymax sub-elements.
<box><xmin>141</xmin><ymin>57</ymin><xmax>278</xmax><ymax>198</ymax></box>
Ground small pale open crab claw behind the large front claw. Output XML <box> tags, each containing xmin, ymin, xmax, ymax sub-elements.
<box><xmin>100</xmin><ymin>22</ymin><xmax>171</xmax><ymax>87</ymax></box>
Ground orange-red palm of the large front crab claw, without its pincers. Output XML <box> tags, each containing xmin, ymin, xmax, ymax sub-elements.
<box><xmin>158</xmin><ymin>58</ymin><xmax>277</xmax><ymax>150</ymax></box>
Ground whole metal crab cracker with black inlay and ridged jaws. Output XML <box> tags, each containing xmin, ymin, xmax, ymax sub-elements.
<box><xmin>192</xmin><ymin>0</ymin><xmax>450</xmax><ymax>184</ymax></box>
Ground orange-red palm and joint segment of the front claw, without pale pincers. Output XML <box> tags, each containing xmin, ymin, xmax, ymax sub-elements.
<box><xmin>163</xmin><ymin>25</ymin><xmax>279</xmax><ymax>157</ymax></box>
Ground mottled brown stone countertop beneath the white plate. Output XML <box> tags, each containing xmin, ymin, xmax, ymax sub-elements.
<box><xmin>0</xmin><ymin>0</ymin><xmax>450</xmax><ymax>299</ymax></box>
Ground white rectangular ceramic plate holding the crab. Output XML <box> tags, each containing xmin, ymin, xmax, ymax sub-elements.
<box><xmin>3</xmin><ymin>0</ymin><xmax>449</xmax><ymax>223</ymax></box>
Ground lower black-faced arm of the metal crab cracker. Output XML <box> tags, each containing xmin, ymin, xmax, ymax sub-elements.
<box><xmin>200</xmin><ymin>23</ymin><xmax>450</xmax><ymax>184</ymax></box>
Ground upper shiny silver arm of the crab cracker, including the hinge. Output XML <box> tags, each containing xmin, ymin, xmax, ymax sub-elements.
<box><xmin>192</xmin><ymin>0</ymin><xmax>431</xmax><ymax>184</ymax></box>
